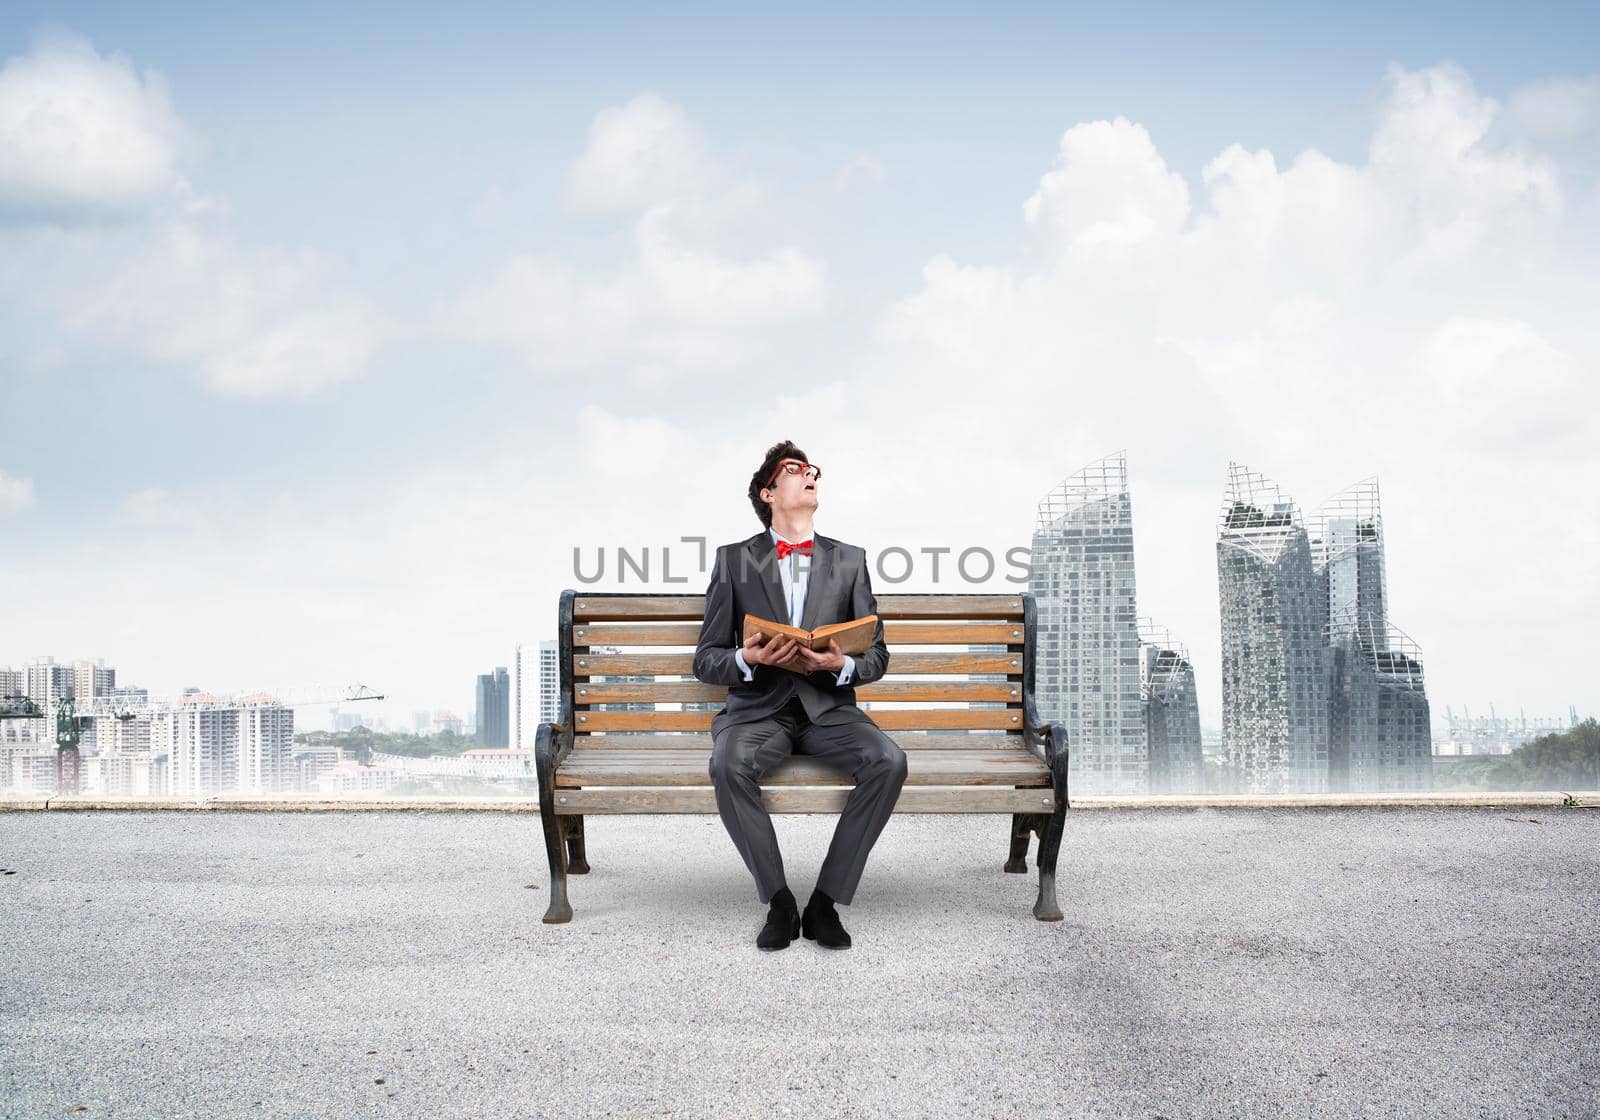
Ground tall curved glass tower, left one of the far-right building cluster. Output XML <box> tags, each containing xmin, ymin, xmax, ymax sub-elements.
<box><xmin>1216</xmin><ymin>462</ymin><xmax>1328</xmax><ymax>794</ymax></box>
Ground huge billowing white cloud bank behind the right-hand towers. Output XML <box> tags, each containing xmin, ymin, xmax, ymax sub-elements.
<box><xmin>876</xmin><ymin>66</ymin><xmax>1600</xmax><ymax>715</ymax></box>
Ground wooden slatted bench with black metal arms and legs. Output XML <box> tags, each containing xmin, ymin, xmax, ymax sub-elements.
<box><xmin>533</xmin><ymin>590</ymin><xmax>1067</xmax><ymax>922</ymax></box>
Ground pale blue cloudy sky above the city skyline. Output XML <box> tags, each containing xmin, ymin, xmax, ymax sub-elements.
<box><xmin>0</xmin><ymin>3</ymin><xmax>1600</xmax><ymax>729</ymax></box>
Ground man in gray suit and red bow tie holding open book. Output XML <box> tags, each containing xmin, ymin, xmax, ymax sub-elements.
<box><xmin>694</xmin><ymin>440</ymin><xmax>906</xmax><ymax>949</ymax></box>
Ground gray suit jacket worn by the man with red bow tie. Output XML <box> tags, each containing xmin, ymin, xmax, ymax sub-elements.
<box><xmin>694</xmin><ymin>530</ymin><xmax>890</xmax><ymax>739</ymax></box>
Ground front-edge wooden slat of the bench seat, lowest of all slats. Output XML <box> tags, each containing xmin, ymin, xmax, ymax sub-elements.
<box><xmin>555</xmin><ymin>786</ymin><xmax>1056</xmax><ymax>816</ymax></box>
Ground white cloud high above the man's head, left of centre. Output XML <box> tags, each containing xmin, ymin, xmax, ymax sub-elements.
<box><xmin>451</xmin><ymin>93</ymin><xmax>827</xmax><ymax>382</ymax></box>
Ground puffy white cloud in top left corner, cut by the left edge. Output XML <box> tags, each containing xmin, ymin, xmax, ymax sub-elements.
<box><xmin>0</xmin><ymin>35</ymin><xmax>189</xmax><ymax>214</ymax></box>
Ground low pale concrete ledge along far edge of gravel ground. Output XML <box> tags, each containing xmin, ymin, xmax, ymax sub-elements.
<box><xmin>0</xmin><ymin>790</ymin><xmax>1600</xmax><ymax>814</ymax></box>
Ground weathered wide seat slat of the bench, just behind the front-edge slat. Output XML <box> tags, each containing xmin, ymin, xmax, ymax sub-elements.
<box><xmin>555</xmin><ymin>747</ymin><xmax>1050</xmax><ymax>787</ymax></box>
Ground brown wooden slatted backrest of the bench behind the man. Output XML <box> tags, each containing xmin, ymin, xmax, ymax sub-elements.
<box><xmin>558</xmin><ymin>590</ymin><xmax>1034</xmax><ymax>749</ymax></box>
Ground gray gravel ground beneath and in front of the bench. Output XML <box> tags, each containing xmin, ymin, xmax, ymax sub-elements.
<box><xmin>0</xmin><ymin>810</ymin><xmax>1600</xmax><ymax>1120</ymax></box>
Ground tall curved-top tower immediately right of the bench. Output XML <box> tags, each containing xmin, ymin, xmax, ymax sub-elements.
<box><xmin>1029</xmin><ymin>454</ymin><xmax>1149</xmax><ymax>794</ymax></box>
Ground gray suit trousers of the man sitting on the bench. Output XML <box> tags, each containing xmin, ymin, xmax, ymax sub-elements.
<box><xmin>710</xmin><ymin>696</ymin><xmax>906</xmax><ymax>906</ymax></box>
